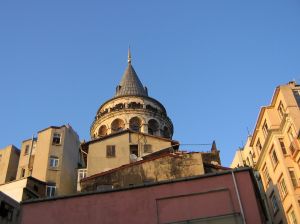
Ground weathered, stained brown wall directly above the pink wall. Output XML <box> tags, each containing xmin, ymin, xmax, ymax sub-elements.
<box><xmin>81</xmin><ymin>153</ymin><xmax>204</xmax><ymax>191</ymax></box>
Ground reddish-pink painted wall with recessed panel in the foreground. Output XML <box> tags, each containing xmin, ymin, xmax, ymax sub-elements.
<box><xmin>21</xmin><ymin>170</ymin><xmax>263</xmax><ymax>224</ymax></box>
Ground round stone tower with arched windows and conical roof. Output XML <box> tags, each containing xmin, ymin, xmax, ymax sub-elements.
<box><xmin>90</xmin><ymin>49</ymin><xmax>173</xmax><ymax>139</ymax></box>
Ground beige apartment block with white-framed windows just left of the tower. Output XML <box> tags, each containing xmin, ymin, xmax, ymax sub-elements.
<box><xmin>17</xmin><ymin>125</ymin><xmax>80</xmax><ymax>197</ymax></box>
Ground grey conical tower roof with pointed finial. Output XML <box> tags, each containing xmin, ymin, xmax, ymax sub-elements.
<box><xmin>115</xmin><ymin>51</ymin><xmax>148</xmax><ymax>97</ymax></box>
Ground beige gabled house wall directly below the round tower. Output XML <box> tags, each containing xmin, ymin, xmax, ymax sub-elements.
<box><xmin>87</xmin><ymin>132</ymin><xmax>171</xmax><ymax>176</ymax></box>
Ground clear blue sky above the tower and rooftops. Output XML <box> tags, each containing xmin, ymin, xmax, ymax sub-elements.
<box><xmin>0</xmin><ymin>0</ymin><xmax>300</xmax><ymax>166</ymax></box>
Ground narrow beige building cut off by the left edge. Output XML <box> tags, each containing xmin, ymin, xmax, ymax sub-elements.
<box><xmin>0</xmin><ymin>145</ymin><xmax>20</xmax><ymax>184</ymax></box>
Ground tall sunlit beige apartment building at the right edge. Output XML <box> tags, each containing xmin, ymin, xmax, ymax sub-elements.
<box><xmin>231</xmin><ymin>82</ymin><xmax>300</xmax><ymax>224</ymax></box>
